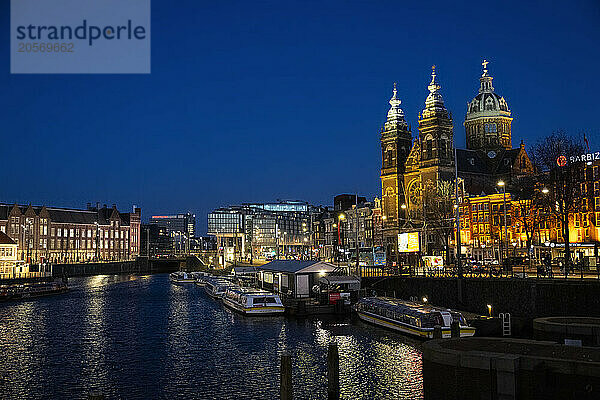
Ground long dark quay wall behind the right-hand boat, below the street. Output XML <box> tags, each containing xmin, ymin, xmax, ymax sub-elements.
<box><xmin>362</xmin><ymin>277</ymin><xmax>600</xmax><ymax>318</ymax></box>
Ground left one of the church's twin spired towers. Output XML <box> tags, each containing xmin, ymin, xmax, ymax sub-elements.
<box><xmin>381</xmin><ymin>83</ymin><xmax>412</xmax><ymax>227</ymax></box>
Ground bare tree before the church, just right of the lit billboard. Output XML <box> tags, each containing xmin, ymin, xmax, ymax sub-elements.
<box><xmin>423</xmin><ymin>180</ymin><xmax>455</xmax><ymax>265</ymax></box>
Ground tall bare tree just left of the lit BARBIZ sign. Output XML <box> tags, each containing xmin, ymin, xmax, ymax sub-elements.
<box><xmin>531</xmin><ymin>131</ymin><xmax>585</xmax><ymax>271</ymax></box>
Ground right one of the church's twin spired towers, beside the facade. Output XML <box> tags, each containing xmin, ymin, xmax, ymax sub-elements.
<box><xmin>404</xmin><ymin>66</ymin><xmax>454</xmax><ymax>216</ymax></box>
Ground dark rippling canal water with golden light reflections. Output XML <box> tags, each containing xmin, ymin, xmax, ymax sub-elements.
<box><xmin>0</xmin><ymin>275</ymin><xmax>423</xmax><ymax>399</ymax></box>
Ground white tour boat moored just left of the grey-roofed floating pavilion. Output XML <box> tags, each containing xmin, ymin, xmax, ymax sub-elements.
<box><xmin>223</xmin><ymin>288</ymin><xmax>285</xmax><ymax>316</ymax></box>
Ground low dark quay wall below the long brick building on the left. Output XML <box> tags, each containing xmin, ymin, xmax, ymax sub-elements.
<box><xmin>52</xmin><ymin>258</ymin><xmax>182</xmax><ymax>277</ymax></box>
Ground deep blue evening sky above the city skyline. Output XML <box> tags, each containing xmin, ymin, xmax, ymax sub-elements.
<box><xmin>0</xmin><ymin>0</ymin><xmax>600</xmax><ymax>233</ymax></box>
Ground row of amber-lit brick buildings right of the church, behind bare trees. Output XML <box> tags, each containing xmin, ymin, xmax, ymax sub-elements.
<box><xmin>460</xmin><ymin>161</ymin><xmax>600</xmax><ymax>267</ymax></box>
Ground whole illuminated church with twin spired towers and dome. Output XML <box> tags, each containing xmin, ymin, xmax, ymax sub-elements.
<box><xmin>381</xmin><ymin>60</ymin><xmax>533</xmax><ymax>257</ymax></box>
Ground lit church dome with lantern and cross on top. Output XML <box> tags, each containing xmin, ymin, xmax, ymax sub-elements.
<box><xmin>464</xmin><ymin>60</ymin><xmax>513</xmax><ymax>151</ymax></box>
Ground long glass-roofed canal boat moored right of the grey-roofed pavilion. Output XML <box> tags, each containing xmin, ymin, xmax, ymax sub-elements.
<box><xmin>354</xmin><ymin>297</ymin><xmax>475</xmax><ymax>339</ymax></box>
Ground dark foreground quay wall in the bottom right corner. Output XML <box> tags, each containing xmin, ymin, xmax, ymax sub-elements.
<box><xmin>422</xmin><ymin>338</ymin><xmax>600</xmax><ymax>400</ymax></box>
